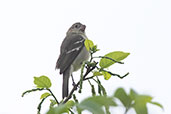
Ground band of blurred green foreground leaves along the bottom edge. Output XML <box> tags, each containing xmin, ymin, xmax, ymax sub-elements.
<box><xmin>48</xmin><ymin>88</ymin><xmax>163</xmax><ymax>114</ymax></box>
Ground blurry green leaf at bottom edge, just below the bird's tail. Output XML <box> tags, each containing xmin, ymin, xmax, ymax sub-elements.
<box><xmin>47</xmin><ymin>101</ymin><xmax>75</xmax><ymax>114</ymax></box>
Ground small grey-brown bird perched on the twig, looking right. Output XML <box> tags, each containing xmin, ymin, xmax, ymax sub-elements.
<box><xmin>55</xmin><ymin>22</ymin><xmax>90</xmax><ymax>98</ymax></box>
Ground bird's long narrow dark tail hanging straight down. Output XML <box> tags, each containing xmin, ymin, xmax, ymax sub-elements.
<box><xmin>62</xmin><ymin>68</ymin><xmax>71</xmax><ymax>99</ymax></box>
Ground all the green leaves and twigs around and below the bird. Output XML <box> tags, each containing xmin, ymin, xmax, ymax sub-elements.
<box><xmin>22</xmin><ymin>39</ymin><xmax>163</xmax><ymax>114</ymax></box>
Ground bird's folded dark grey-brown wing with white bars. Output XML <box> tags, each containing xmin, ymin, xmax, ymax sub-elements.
<box><xmin>56</xmin><ymin>34</ymin><xmax>85</xmax><ymax>74</ymax></box>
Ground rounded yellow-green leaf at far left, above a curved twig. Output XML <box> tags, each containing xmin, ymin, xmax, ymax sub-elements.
<box><xmin>34</xmin><ymin>76</ymin><xmax>51</xmax><ymax>88</ymax></box>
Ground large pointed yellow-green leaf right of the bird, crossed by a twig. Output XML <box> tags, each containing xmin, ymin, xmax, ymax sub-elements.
<box><xmin>100</xmin><ymin>51</ymin><xmax>130</xmax><ymax>68</ymax></box>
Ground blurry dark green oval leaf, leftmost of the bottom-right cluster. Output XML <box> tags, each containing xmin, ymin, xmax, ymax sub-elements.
<box><xmin>114</xmin><ymin>88</ymin><xmax>132</xmax><ymax>108</ymax></box>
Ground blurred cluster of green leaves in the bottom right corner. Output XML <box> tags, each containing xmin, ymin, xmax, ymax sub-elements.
<box><xmin>114</xmin><ymin>88</ymin><xmax>163</xmax><ymax>114</ymax></box>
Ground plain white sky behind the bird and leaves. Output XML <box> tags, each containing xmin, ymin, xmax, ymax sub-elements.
<box><xmin>0</xmin><ymin>0</ymin><xmax>171</xmax><ymax>114</ymax></box>
